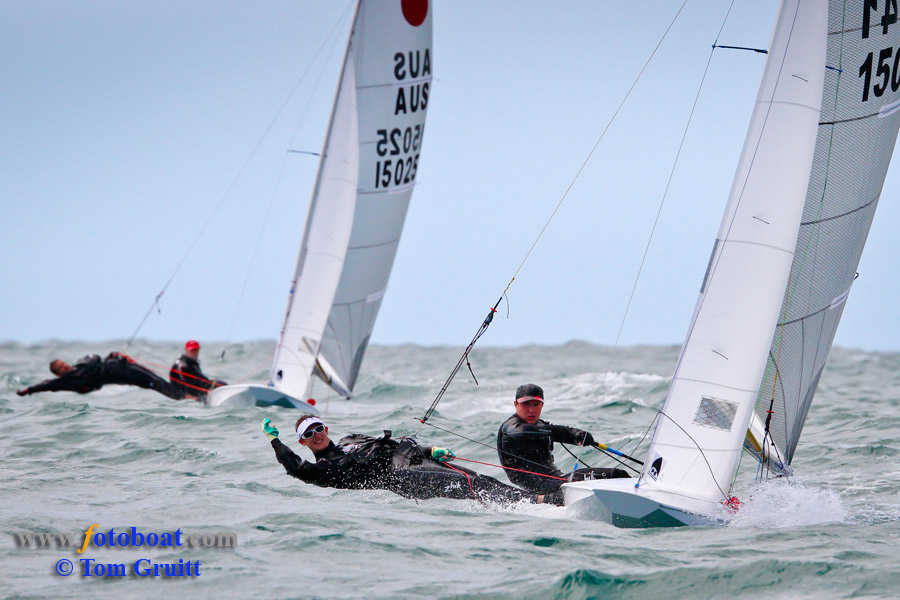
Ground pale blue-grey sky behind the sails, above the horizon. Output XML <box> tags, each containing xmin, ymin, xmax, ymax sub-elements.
<box><xmin>0</xmin><ymin>0</ymin><xmax>900</xmax><ymax>349</ymax></box>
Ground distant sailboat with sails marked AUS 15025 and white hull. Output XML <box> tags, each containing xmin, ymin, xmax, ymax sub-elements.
<box><xmin>208</xmin><ymin>0</ymin><xmax>432</xmax><ymax>412</ymax></box>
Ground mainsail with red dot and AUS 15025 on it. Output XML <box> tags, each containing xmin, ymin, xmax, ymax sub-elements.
<box><xmin>318</xmin><ymin>0</ymin><xmax>432</xmax><ymax>396</ymax></box>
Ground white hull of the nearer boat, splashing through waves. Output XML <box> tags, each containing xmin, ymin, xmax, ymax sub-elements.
<box><xmin>562</xmin><ymin>478</ymin><xmax>724</xmax><ymax>527</ymax></box>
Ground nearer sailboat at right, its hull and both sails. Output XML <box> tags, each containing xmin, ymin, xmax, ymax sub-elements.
<box><xmin>563</xmin><ymin>0</ymin><xmax>900</xmax><ymax>527</ymax></box>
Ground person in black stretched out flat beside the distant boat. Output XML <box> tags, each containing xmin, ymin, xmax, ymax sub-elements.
<box><xmin>16</xmin><ymin>352</ymin><xmax>184</xmax><ymax>400</ymax></box>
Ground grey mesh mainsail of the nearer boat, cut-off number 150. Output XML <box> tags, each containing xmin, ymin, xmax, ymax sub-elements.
<box><xmin>756</xmin><ymin>0</ymin><xmax>900</xmax><ymax>471</ymax></box>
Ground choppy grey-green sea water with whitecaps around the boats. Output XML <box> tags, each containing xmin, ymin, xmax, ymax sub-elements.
<box><xmin>0</xmin><ymin>342</ymin><xmax>900</xmax><ymax>599</ymax></box>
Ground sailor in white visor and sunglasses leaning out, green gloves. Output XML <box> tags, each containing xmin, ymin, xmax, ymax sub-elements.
<box><xmin>262</xmin><ymin>415</ymin><xmax>543</xmax><ymax>503</ymax></box>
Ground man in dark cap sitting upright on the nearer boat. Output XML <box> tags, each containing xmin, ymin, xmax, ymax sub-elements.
<box><xmin>497</xmin><ymin>383</ymin><xmax>629</xmax><ymax>504</ymax></box>
